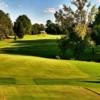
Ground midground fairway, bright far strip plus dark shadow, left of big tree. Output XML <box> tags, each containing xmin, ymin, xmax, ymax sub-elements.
<box><xmin>0</xmin><ymin>34</ymin><xmax>60</xmax><ymax>58</ymax></box>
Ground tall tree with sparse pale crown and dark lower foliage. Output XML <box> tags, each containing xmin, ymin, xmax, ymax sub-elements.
<box><xmin>55</xmin><ymin>0</ymin><xmax>100</xmax><ymax>60</ymax></box>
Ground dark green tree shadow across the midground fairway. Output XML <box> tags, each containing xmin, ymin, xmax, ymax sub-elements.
<box><xmin>1</xmin><ymin>39</ymin><xmax>60</xmax><ymax>58</ymax></box>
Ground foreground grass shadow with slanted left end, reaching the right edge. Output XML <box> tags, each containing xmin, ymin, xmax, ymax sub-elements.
<box><xmin>33</xmin><ymin>79</ymin><xmax>100</xmax><ymax>85</ymax></box>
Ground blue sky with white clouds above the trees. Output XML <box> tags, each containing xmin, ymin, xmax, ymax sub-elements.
<box><xmin>0</xmin><ymin>0</ymin><xmax>100</xmax><ymax>24</ymax></box>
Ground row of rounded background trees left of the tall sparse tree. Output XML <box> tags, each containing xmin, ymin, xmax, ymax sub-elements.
<box><xmin>0</xmin><ymin>10</ymin><xmax>69</xmax><ymax>39</ymax></box>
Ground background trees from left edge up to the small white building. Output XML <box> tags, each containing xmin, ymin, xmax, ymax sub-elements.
<box><xmin>0</xmin><ymin>10</ymin><xmax>45</xmax><ymax>39</ymax></box>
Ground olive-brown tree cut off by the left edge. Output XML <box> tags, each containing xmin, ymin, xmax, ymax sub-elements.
<box><xmin>0</xmin><ymin>10</ymin><xmax>13</xmax><ymax>39</ymax></box>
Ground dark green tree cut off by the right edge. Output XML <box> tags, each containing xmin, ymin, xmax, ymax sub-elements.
<box><xmin>92</xmin><ymin>7</ymin><xmax>100</xmax><ymax>45</ymax></box>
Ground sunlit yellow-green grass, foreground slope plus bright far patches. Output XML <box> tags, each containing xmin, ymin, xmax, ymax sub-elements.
<box><xmin>0</xmin><ymin>36</ymin><xmax>100</xmax><ymax>100</ymax></box>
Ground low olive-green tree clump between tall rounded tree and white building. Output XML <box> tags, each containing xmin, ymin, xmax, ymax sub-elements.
<box><xmin>32</xmin><ymin>23</ymin><xmax>45</xmax><ymax>35</ymax></box>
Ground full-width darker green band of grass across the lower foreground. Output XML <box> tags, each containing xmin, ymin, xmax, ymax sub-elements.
<box><xmin>0</xmin><ymin>77</ymin><xmax>100</xmax><ymax>88</ymax></box>
